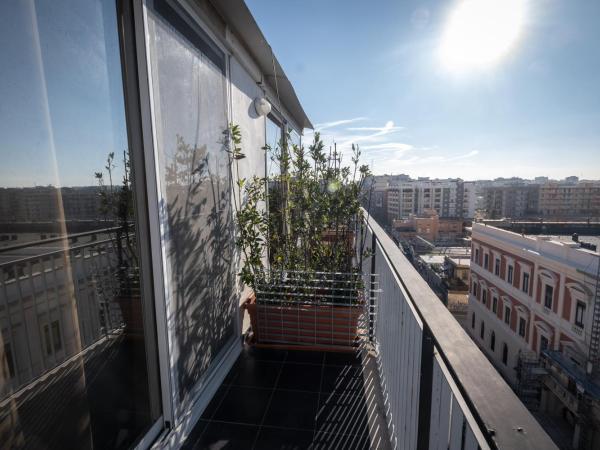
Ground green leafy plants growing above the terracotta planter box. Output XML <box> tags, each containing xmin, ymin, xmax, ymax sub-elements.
<box><xmin>224</xmin><ymin>125</ymin><xmax>370</xmax><ymax>298</ymax></box>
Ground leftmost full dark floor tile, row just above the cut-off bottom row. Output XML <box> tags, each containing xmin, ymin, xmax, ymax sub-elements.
<box><xmin>212</xmin><ymin>386</ymin><xmax>272</xmax><ymax>425</ymax></box>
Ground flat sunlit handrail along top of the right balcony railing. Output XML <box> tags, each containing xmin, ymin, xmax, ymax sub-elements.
<box><xmin>365</xmin><ymin>214</ymin><xmax>557</xmax><ymax>450</ymax></box>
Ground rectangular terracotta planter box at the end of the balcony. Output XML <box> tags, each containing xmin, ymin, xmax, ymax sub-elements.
<box><xmin>245</xmin><ymin>296</ymin><xmax>364</xmax><ymax>350</ymax></box>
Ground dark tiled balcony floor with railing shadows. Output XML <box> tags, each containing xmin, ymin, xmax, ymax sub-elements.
<box><xmin>184</xmin><ymin>347</ymin><xmax>390</xmax><ymax>450</ymax></box>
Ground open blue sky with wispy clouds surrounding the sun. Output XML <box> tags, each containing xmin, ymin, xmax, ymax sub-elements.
<box><xmin>247</xmin><ymin>0</ymin><xmax>600</xmax><ymax>179</ymax></box>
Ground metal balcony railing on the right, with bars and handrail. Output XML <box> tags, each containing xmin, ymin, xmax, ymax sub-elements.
<box><xmin>360</xmin><ymin>213</ymin><xmax>556</xmax><ymax>450</ymax></box>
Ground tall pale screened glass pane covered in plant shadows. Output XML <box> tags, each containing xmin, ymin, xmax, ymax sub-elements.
<box><xmin>148</xmin><ymin>1</ymin><xmax>236</xmax><ymax>402</ymax></box>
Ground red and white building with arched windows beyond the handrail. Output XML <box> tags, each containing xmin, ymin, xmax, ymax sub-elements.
<box><xmin>467</xmin><ymin>223</ymin><xmax>600</xmax><ymax>448</ymax></box>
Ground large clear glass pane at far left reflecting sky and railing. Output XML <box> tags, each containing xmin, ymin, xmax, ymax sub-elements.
<box><xmin>0</xmin><ymin>0</ymin><xmax>160</xmax><ymax>449</ymax></box>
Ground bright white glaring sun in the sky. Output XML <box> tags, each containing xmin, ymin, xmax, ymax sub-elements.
<box><xmin>439</xmin><ymin>0</ymin><xmax>525</xmax><ymax>70</ymax></box>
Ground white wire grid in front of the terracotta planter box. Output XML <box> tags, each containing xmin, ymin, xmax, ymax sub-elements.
<box><xmin>255</xmin><ymin>271</ymin><xmax>379</xmax><ymax>350</ymax></box>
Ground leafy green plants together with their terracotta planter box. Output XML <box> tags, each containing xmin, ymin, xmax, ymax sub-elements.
<box><xmin>227</xmin><ymin>125</ymin><xmax>370</xmax><ymax>348</ymax></box>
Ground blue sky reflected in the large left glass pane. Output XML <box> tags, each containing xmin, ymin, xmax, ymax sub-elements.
<box><xmin>0</xmin><ymin>0</ymin><xmax>127</xmax><ymax>187</ymax></box>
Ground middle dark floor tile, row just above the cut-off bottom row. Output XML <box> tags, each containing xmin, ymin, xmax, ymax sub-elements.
<box><xmin>264</xmin><ymin>390</ymin><xmax>319</xmax><ymax>432</ymax></box>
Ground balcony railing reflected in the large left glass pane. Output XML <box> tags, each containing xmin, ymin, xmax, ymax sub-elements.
<box><xmin>0</xmin><ymin>229</ymin><xmax>132</xmax><ymax>402</ymax></box>
